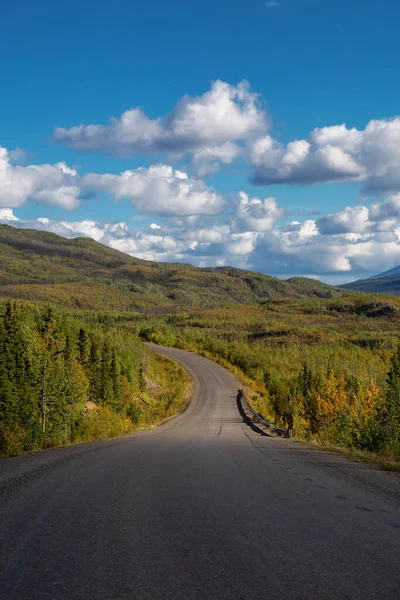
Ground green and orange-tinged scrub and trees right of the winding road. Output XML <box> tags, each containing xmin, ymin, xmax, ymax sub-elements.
<box><xmin>136</xmin><ymin>294</ymin><xmax>400</xmax><ymax>465</ymax></box>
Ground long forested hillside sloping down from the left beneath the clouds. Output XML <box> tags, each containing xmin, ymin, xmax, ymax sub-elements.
<box><xmin>0</xmin><ymin>225</ymin><xmax>343</xmax><ymax>313</ymax></box>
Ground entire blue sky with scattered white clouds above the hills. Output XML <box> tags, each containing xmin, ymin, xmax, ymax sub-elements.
<box><xmin>0</xmin><ymin>0</ymin><xmax>400</xmax><ymax>283</ymax></box>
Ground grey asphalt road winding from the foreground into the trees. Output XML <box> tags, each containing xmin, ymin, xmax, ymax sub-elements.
<box><xmin>0</xmin><ymin>349</ymin><xmax>400</xmax><ymax>600</ymax></box>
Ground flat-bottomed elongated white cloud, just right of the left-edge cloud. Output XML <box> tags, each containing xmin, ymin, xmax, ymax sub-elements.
<box><xmin>83</xmin><ymin>164</ymin><xmax>224</xmax><ymax>216</ymax></box>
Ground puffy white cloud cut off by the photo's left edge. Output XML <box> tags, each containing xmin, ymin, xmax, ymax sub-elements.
<box><xmin>0</xmin><ymin>147</ymin><xmax>80</xmax><ymax>210</ymax></box>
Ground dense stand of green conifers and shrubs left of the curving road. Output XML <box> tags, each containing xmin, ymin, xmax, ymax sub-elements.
<box><xmin>0</xmin><ymin>302</ymin><xmax>187</xmax><ymax>455</ymax></box>
